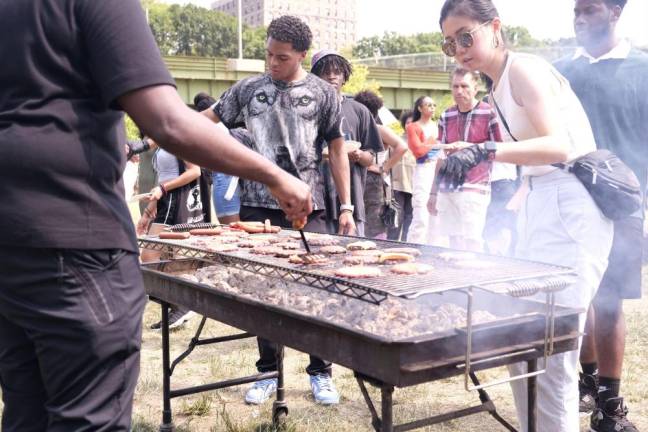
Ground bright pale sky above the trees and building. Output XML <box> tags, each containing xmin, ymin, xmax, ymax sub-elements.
<box><xmin>172</xmin><ymin>0</ymin><xmax>648</xmax><ymax>46</ymax></box>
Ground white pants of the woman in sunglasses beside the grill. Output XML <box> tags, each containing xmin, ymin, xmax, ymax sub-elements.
<box><xmin>509</xmin><ymin>171</ymin><xmax>612</xmax><ymax>432</ymax></box>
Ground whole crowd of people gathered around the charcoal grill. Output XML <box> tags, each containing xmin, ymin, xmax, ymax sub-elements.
<box><xmin>0</xmin><ymin>0</ymin><xmax>648</xmax><ymax>432</ymax></box>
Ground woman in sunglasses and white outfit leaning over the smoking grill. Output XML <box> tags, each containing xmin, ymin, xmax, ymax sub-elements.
<box><xmin>439</xmin><ymin>0</ymin><xmax>612</xmax><ymax>432</ymax></box>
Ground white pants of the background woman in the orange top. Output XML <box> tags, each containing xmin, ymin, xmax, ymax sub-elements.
<box><xmin>407</xmin><ymin>159</ymin><xmax>436</xmax><ymax>244</ymax></box>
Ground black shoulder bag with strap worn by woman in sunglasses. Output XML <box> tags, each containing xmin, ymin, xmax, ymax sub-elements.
<box><xmin>490</xmin><ymin>92</ymin><xmax>642</xmax><ymax>220</ymax></box>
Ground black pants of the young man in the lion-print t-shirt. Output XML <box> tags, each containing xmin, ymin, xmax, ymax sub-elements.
<box><xmin>240</xmin><ymin>206</ymin><xmax>332</xmax><ymax>375</ymax></box>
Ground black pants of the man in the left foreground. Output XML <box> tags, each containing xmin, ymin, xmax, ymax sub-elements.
<box><xmin>0</xmin><ymin>247</ymin><xmax>146</xmax><ymax>432</ymax></box>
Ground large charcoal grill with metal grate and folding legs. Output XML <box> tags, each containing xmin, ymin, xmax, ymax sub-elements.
<box><xmin>140</xmin><ymin>231</ymin><xmax>582</xmax><ymax>432</ymax></box>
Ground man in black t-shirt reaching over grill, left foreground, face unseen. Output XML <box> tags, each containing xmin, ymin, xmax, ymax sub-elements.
<box><xmin>0</xmin><ymin>0</ymin><xmax>311</xmax><ymax>432</ymax></box>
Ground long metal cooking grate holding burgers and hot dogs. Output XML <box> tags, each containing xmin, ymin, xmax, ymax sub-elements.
<box><xmin>139</xmin><ymin>230</ymin><xmax>574</xmax><ymax>304</ymax></box>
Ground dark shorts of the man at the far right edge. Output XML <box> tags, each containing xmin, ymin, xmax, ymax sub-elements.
<box><xmin>596</xmin><ymin>217</ymin><xmax>643</xmax><ymax>302</ymax></box>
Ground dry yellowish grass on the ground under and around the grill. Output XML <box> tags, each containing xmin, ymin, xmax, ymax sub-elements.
<box><xmin>0</xmin><ymin>267</ymin><xmax>648</xmax><ymax>432</ymax></box>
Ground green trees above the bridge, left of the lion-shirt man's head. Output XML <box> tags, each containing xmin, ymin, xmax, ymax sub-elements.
<box><xmin>141</xmin><ymin>0</ymin><xmax>266</xmax><ymax>59</ymax></box>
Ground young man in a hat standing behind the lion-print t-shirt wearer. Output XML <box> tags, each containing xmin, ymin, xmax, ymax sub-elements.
<box><xmin>311</xmin><ymin>50</ymin><xmax>383</xmax><ymax>237</ymax></box>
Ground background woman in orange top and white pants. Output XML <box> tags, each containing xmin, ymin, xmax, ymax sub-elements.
<box><xmin>405</xmin><ymin>96</ymin><xmax>439</xmax><ymax>243</ymax></box>
